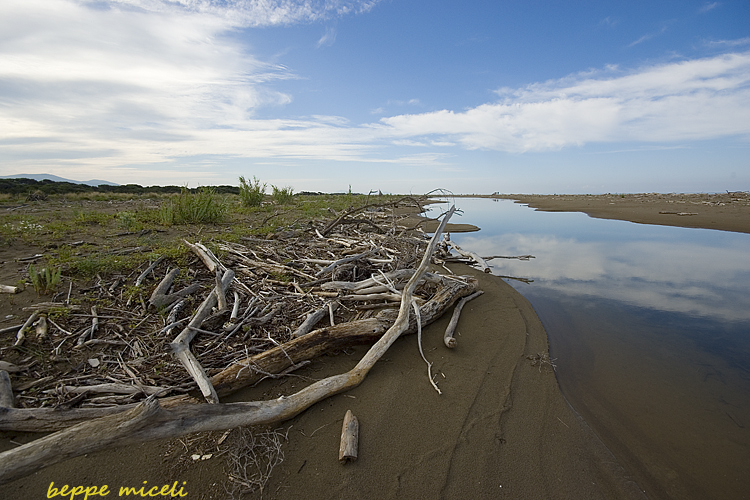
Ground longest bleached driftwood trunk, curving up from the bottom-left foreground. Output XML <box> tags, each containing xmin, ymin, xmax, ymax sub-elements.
<box><xmin>0</xmin><ymin>207</ymin><xmax>455</xmax><ymax>483</ymax></box>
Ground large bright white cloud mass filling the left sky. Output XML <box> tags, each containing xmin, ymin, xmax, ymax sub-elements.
<box><xmin>0</xmin><ymin>0</ymin><xmax>376</xmax><ymax>179</ymax></box>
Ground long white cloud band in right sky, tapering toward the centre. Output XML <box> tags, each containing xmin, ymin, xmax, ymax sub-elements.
<box><xmin>380</xmin><ymin>52</ymin><xmax>750</xmax><ymax>152</ymax></box>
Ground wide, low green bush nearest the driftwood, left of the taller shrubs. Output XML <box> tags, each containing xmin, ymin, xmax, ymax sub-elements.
<box><xmin>159</xmin><ymin>187</ymin><xmax>229</xmax><ymax>225</ymax></box>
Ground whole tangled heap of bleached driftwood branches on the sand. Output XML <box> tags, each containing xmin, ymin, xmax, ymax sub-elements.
<box><xmin>0</xmin><ymin>199</ymin><xmax>477</xmax><ymax>483</ymax></box>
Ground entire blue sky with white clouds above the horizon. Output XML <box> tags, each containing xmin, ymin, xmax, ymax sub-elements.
<box><xmin>0</xmin><ymin>0</ymin><xmax>750</xmax><ymax>194</ymax></box>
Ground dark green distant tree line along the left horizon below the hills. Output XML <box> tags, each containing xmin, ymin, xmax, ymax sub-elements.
<box><xmin>0</xmin><ymin>178</ymin><xmax>240</xmax><ymax>196</ymax></box>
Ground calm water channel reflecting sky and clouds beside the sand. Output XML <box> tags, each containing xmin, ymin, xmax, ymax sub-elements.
<box><xmin>452</xmin><ymin>199</ymin><xmax>750</xmax><ymax>499</ymax></box>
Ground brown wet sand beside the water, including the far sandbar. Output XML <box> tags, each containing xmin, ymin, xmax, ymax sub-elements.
<box><xmin>0</xmin><ymin>194</ymin><xmax>750</xmax><ymax>499</ymax></box>
